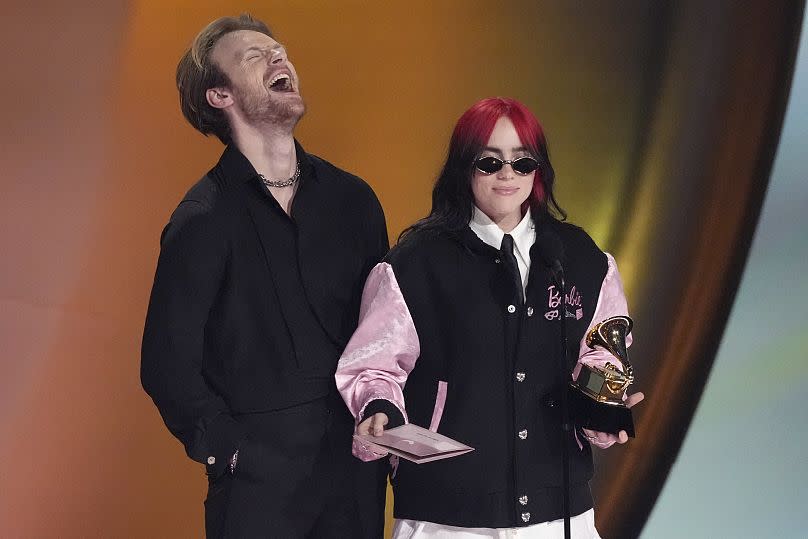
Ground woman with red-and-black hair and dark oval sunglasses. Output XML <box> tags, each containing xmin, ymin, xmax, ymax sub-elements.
<box><xmin>336</xmin><ymin>98</ymin><xmax>642</xmax><ymax>538</ymax></box>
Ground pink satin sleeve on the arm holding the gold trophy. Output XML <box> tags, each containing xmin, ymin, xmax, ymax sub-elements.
<box><xmin>572</xmin><ymin>253</ymin><xmax>633</xmax><ymax>449</ymax></box>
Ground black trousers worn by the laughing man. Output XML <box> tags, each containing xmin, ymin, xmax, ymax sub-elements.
<box><xmin>205</xmin><ymin>396</ymin><xmax>387</xmax><ymax>539</ymax></box>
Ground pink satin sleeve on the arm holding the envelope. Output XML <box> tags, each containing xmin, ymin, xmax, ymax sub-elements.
<box><xmin>335</xmin><ymin>262</ymin><xmax>421</xmax><ymax>460</ymax></box>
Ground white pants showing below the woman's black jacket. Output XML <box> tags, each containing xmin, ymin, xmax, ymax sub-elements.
<box><xmin>393</xmin><ymin>509</ymin><xmax>600</xmax><ymax>539</ymax></box>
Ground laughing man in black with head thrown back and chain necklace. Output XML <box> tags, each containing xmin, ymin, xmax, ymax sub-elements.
<box><xmin>141</xmin><ymin>15</ymin><xmax>388</xmax><ymax>538</ymax></box>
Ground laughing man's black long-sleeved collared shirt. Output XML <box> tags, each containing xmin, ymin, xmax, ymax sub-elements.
<box><xmin>141</xmin><ymin>145</ymin><xmax>388</xmax><ymax>476</ymax></box>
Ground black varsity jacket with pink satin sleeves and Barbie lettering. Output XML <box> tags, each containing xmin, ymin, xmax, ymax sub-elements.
<box><xmin>336</xmin><ymin>217</ymin><xmax>627</xmax><ymax>528</ymax></box>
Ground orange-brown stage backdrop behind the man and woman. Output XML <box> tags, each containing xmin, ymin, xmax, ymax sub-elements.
<box><xmin>0</xmin><ymin>0</ymin><xmax>803</xmax><ymax>537</ymax></box>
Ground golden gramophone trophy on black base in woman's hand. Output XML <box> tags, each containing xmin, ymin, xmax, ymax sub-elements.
<box><xmin>570</xmin><ymin>316</ymin><xmax>634</xmax><ymax>437</ymax></box>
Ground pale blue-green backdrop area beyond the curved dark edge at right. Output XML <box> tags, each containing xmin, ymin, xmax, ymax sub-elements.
<box><xmin>642</xmin><ymin>11</ymin><xmax>808</xmax><ymax>539</ymax></box>
